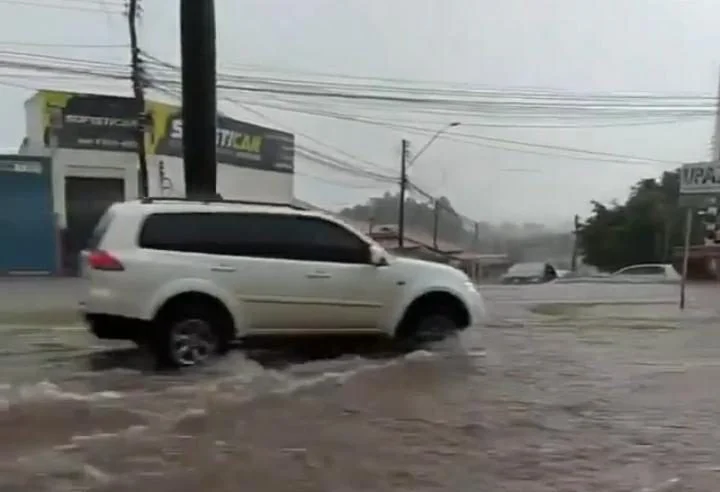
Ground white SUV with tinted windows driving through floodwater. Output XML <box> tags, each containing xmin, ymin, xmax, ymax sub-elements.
<box><xmin>80</xmin><ymin>198</ymin><xmax>484</xmax><ymax>366</ymax></box>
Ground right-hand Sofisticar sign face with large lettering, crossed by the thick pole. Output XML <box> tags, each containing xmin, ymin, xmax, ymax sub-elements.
<box><xmin>149</xmin><ymin>103</ymin><xmax>295</xmax><ymax>173</ymax></box>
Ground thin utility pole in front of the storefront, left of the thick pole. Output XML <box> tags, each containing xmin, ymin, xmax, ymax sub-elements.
<box><xmin>128</xmin><ymin>0</ymin><xmax>149</xmax><ymax>196</ymax></box>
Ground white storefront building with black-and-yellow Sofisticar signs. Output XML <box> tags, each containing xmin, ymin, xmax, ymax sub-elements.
<box><xmin>14</xmin><ymin>91</ymin><xmax>294</xmax><ymax>274</ymax></box>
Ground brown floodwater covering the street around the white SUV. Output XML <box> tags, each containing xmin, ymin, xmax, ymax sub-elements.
<box><xmin>0</xmin><ymin>281</ymin><xmax>720</xmax><ymax>492</ymax></box>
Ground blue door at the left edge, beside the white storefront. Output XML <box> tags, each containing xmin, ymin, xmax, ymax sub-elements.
<box><xmin>0</xmin><ymin>156</ymin><xmax>58</xmax><ymax>275</ymax></box>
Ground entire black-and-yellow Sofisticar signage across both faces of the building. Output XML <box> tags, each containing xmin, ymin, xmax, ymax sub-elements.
<box><xmin>35</xmin><ymin>91</ymin><xmax>295</xmax><ymax>174</ymax></box>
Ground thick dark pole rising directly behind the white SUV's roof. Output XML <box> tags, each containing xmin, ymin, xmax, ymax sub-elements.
<box><xmin>180</xmin><ymin>0</ymin><xmax>217</xmax><ymax>198</ymax></box>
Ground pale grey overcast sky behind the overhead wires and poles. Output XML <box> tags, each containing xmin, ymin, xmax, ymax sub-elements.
<box><xmin>0</xmin><ymin>0</ymin><xmax>720</xmax><ymax>227</ymax></box>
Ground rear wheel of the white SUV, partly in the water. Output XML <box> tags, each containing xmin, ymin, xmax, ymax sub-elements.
<box><xmin>150</xmin><ymin>303</ymin><xmax>229</xmax><ymax>368</ymax></box>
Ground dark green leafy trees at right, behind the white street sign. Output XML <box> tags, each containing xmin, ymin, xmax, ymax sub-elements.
<box><xmin>579</xmin><ymin>170</ymin><xmax>703</xmax><ymax>271</ymax></box>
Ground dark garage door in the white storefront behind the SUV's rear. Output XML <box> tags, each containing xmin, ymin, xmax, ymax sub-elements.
<box><xmin>63</xmin><ymin>177</ymin><xmax>125</xmax><ymax>275</ymax></box>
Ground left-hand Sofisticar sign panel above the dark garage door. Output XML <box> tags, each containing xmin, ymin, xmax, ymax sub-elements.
<box><xmin>42</xmin><ymin>91</ymin><xmax>141</xmax><ymax>152</ymax></box>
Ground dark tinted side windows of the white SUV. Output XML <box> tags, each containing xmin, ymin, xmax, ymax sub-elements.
<box><xmin>138</xmin><ymin>212</ymin><xmax>370</xmax><ymax>263</ymax></box>
